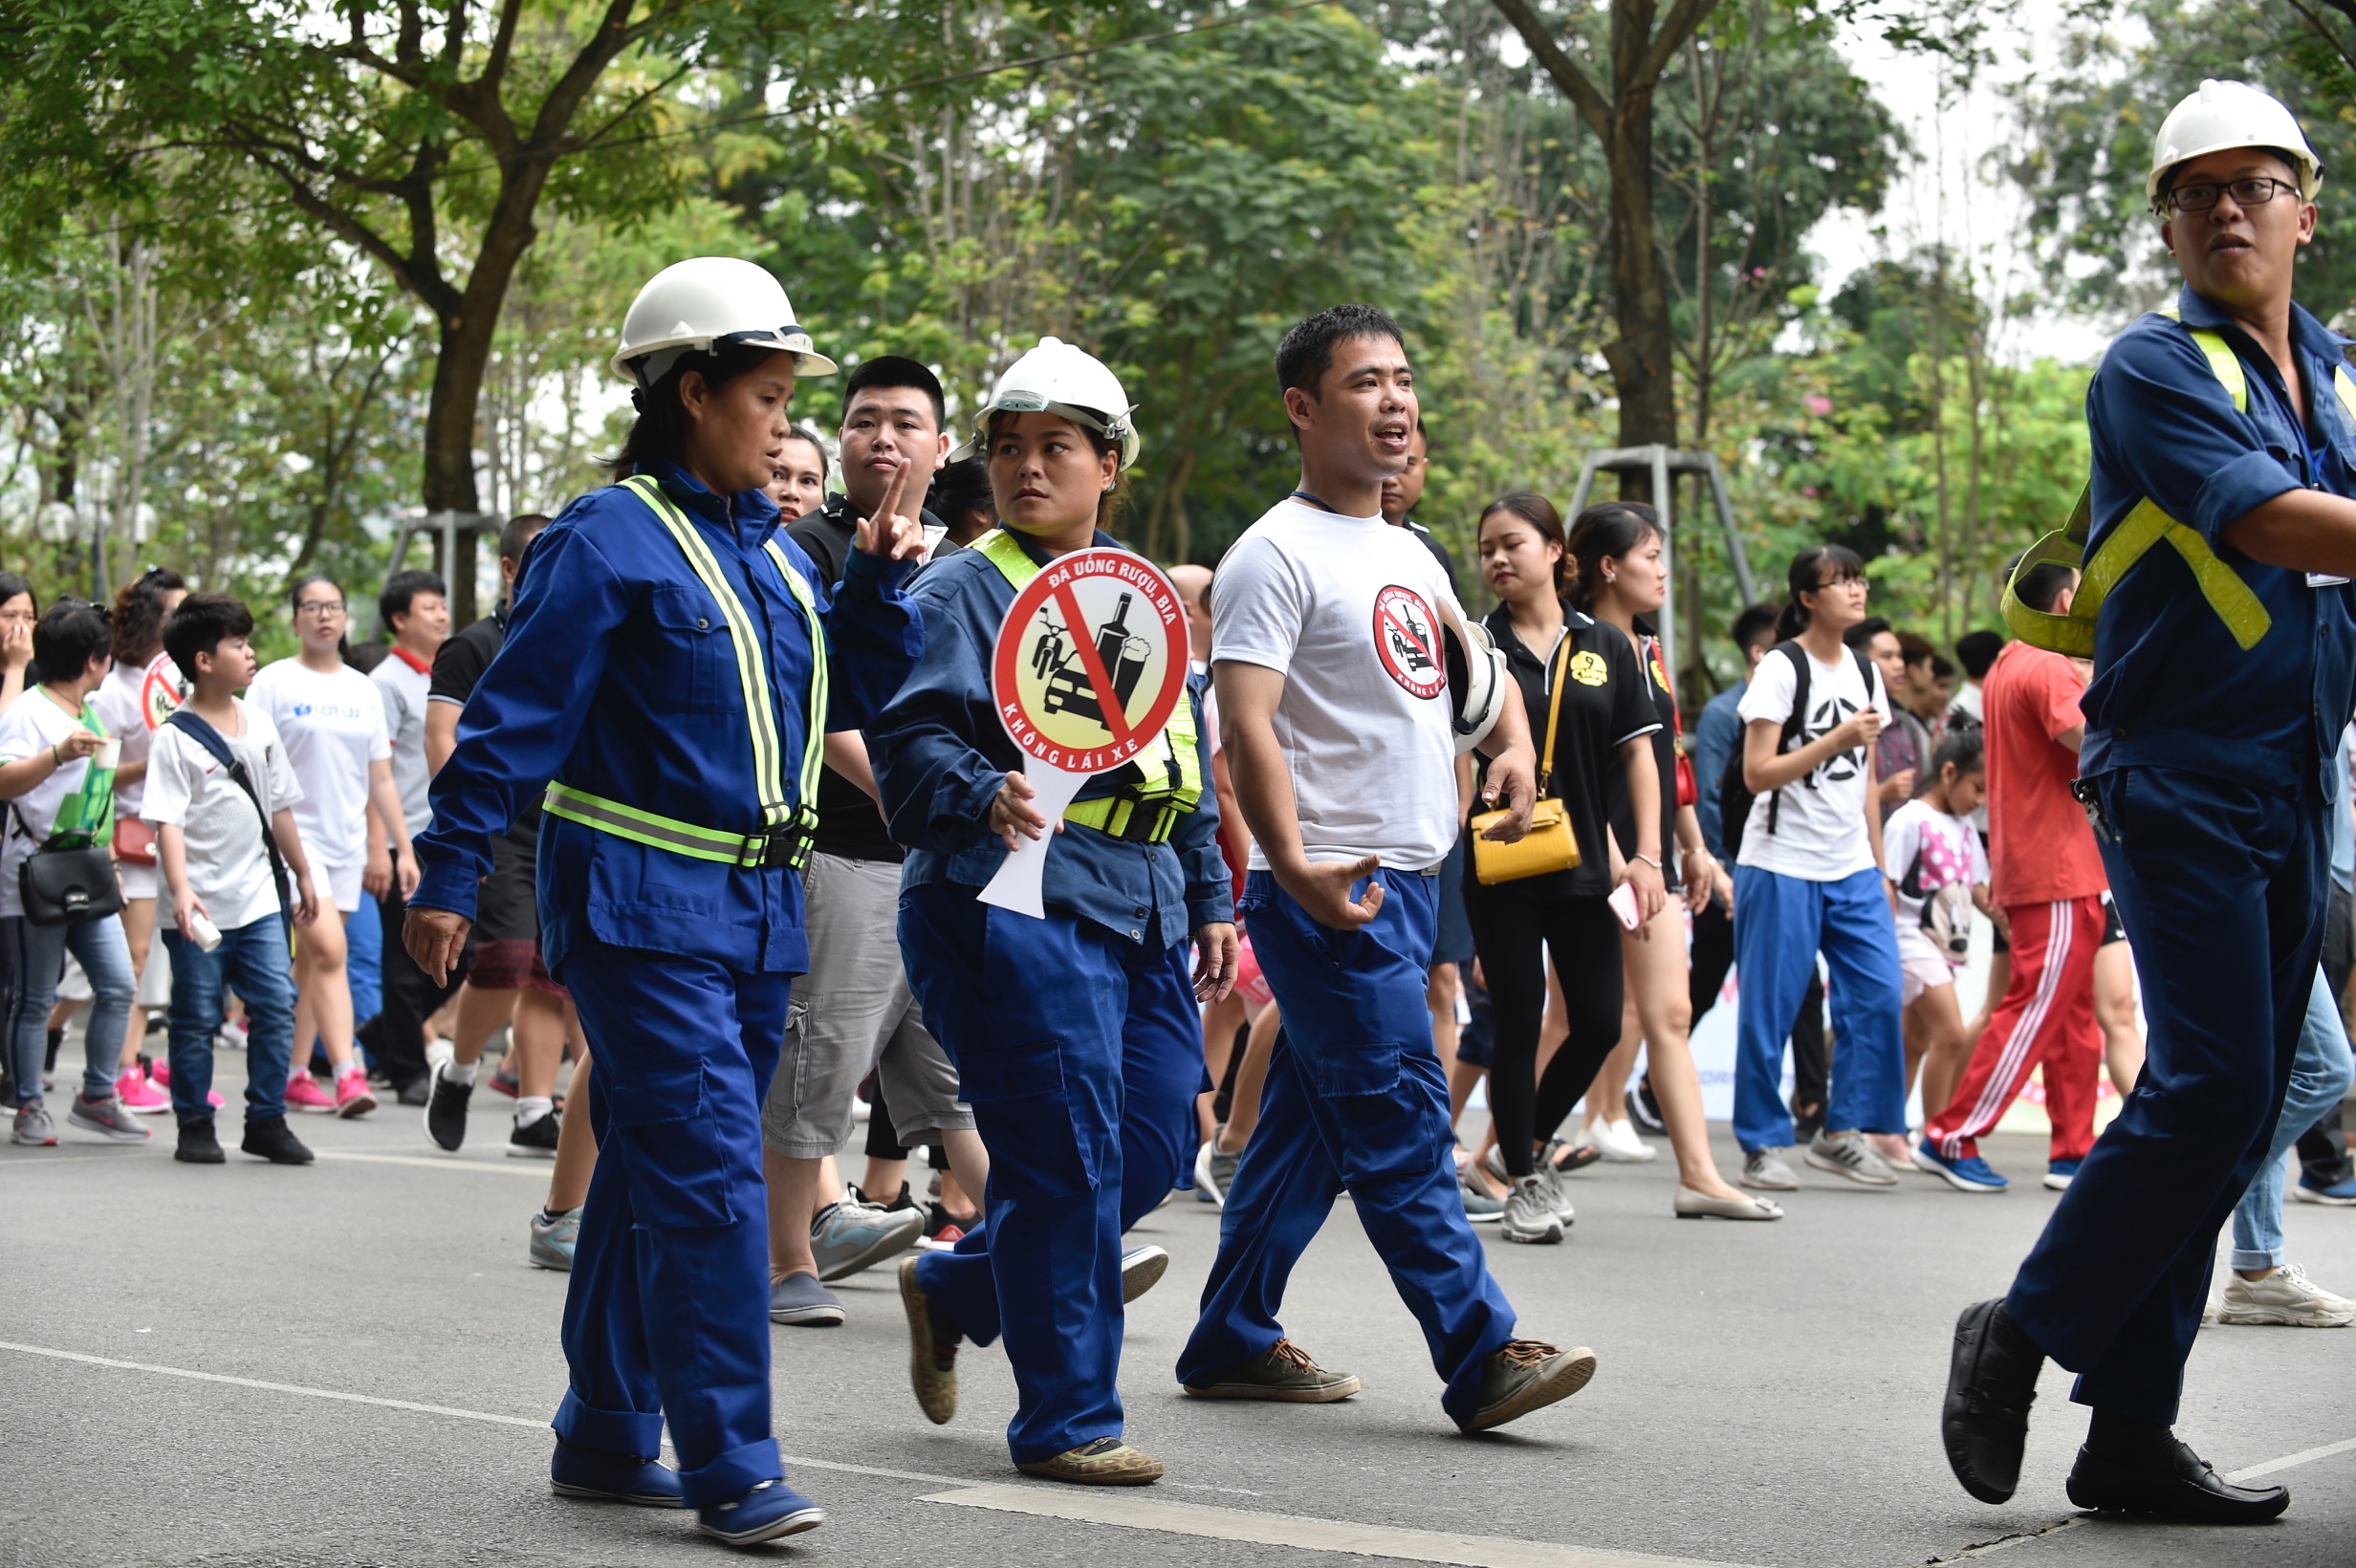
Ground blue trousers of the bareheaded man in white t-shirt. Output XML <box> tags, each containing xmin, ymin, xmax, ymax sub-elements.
<box><xmin>1178</xmin><ymin>871</ymin><xmax>1515</xmax><ymax>1425</ymax></box>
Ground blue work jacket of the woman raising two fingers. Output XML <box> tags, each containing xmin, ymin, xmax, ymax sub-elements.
<box><xmin>410</xmin><ymin>451</ymin><xmax>924</xmax><ymax>974</ymax></box>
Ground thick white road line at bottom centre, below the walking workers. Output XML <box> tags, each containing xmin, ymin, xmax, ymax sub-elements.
<box><xmin>919</xmin><ymin>1486</ymin><xmax>1771</xmax><ymax>1568</ymax></box>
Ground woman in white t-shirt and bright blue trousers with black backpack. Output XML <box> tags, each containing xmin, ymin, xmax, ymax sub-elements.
<box><xmin>1734</xmin><ymin>544</ymin><xmax>1906</xmax><ymax>1191</ymax></box>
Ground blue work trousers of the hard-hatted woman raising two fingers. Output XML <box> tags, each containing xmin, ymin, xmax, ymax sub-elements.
<box><xmin>554</xmin><ymin>942</ymin><xmax>794</xmax><ymax>1509</ymax></box>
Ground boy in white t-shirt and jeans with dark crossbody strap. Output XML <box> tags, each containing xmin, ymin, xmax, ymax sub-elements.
<box><xmin>139</xmin><ymin>594</ymin><xmax>318</xmax><ymax>1165</ymax></box>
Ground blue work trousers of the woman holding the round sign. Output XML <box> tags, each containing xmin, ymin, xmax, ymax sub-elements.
<box><xmin>900</xmin><ymin>882</ymin><xmax>1207</xmax><ymax>1465</ymax></box>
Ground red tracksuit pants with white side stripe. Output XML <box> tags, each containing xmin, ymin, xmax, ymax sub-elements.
<box><xmin>1923</xmin><ymin>897</ymin><xmax>2104</xmax><ymax>1161</ymax></box>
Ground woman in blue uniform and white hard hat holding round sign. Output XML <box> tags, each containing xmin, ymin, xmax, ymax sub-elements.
<box><xmin>867</xmin><ymin>337</ymin><xmax>1237</xmax><ymax>1486</ymax></box>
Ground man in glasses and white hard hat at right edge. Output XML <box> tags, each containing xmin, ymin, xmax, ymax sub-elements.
<box><xmin>1941</xmin><ymin>82</ymin><xmax>2356</xmax><ymax>1523</ymax></box>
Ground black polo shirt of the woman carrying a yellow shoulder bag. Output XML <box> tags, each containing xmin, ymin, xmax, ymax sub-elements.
<box><xmin>1466</xmin><ymin>605</ymin><xmax>1675</xmax><ymax>900</ymax></box>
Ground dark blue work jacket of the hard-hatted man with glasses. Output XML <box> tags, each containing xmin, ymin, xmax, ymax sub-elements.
<box><xmin>2078</xmin><ymin>287</ymin><xmax>2356</xmax><ymax>800</ymax></box>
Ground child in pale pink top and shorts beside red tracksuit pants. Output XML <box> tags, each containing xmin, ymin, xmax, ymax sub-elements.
<box><xmin>1883</xmin><ymin>730</ymin><xmax>2005</xmax><ymax>1143</ymax></box>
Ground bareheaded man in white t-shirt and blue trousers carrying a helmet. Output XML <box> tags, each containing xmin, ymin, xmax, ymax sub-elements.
<box><xmin>1178</xmin><ymin>306</ymin><xmax>1595</xmax><ymax>1431</ymax></box>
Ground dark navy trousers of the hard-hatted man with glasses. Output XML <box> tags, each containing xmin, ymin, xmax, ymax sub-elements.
<box><xmin>2005</xmin><ymin>768</ymin><xmax>2345</xmax><ymax>1422</ymax></box>
